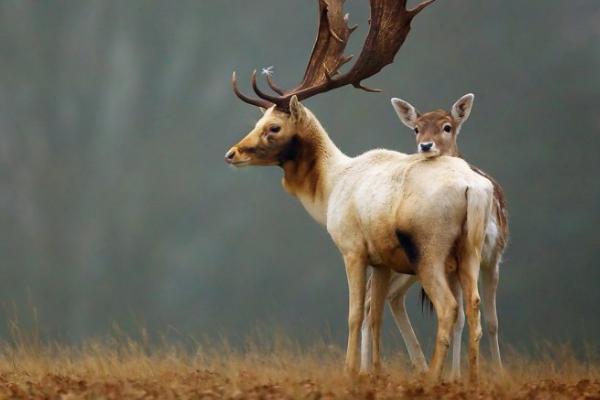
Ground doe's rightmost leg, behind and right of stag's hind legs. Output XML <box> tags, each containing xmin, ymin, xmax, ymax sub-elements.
<box><xmin>481</xmin><ymin>262</ymin><xmax>502</xmax><ymax>369</ymax></box>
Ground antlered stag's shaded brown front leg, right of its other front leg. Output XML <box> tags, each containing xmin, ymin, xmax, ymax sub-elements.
<box><xmin>369</xmin><ymin>266</ymin><xmax>391</xmax><ymax>371</ymax></box>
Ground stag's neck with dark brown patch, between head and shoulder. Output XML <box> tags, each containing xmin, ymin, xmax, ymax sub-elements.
<box><xmin>281</xmin><ymin>117</ymin><xmax>348</xmax><ymax>225</ymax></box>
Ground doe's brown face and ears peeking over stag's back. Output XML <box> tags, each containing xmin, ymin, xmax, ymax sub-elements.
<box><xmin>392</xmin><ymin>93</ymin><xmax>475</xmax><ymax>157</ymax></box>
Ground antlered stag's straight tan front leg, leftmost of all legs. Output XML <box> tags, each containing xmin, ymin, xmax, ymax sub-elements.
<box><xmin>344</xmin><ymin>254</ymin><xmax>367</xmax><ymax>374</ymax></box>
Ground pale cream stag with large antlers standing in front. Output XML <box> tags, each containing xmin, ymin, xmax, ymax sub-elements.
<box><xmin>225</xmin><ymin>0</ymin><xmax>493</xmax><ymax>381</ymax></box>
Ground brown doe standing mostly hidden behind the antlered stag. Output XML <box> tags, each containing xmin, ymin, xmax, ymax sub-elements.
<box><xmin>361</xmin><ymin>93</ymin><xmax>509</xmax><ymax>379</ymax></box>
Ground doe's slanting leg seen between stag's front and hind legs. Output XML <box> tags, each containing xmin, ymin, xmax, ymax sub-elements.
<box><xmin>388</xmin><ymin>274</ymin><xmax>427</xmax><ymax>372</ymax></box>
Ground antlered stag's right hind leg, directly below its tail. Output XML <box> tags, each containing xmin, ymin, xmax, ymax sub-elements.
<box><xmin>458</xmin><ymin>254</ymin><xmax>481</xmax><ymax>382</ymax></box>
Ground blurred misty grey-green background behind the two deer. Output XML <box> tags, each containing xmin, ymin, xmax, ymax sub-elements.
<box><xmin>0</xmin><ymin>0</ymin><xmax>600</xmax><ymax>349</ymax></box>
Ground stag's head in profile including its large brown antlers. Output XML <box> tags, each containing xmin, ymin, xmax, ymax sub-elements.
<box><xmin>225</xmin><ymin>0</ymin><xmax>435</xmax><ymax>166</ymax></box>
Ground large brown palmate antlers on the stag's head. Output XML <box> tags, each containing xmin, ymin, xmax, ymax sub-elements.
<box><xmin>232</xmin><ymin>0</ymin><xmax>435</xmax><ymax>111</ymax></box>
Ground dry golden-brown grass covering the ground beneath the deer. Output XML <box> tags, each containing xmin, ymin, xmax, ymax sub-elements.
<box><xmin>0</xmin><ymin>326</ymin><xmax>600</xmax><ymax>399</ymax></box>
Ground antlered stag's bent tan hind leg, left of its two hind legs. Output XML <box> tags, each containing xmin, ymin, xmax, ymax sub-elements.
<box><xmin>419</xmin><ymin>262</ymin><xmax>458</xmax><ymax>381</ymax></box>
